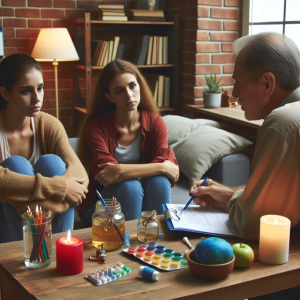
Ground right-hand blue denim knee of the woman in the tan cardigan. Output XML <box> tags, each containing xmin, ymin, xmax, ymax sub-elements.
<box><xmin>34</xmin><ymin>154</ymin><xmax>66</xmax><ymax>177</ymax></box>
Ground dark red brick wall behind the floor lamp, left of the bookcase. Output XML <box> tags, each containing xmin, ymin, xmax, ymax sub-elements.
<box><xmin>0</xmin><ymin>0</ymin><xmax>134</xmax><ymax>136</ymax></box>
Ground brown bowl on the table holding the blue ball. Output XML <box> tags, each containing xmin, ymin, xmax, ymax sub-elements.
<box><xmin>186</xmin><ymin>249</ymin><xmax>235</xmax><ymax>279</ymax></box>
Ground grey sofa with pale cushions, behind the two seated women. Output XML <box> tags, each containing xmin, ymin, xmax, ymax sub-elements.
<box><xmin>0</xmin><ymin>116</ymin><xmax>251</xmax><ymax>243</ymax></box>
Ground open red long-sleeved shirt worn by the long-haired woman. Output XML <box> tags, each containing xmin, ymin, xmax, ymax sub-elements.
<box><xmin>78</xmin><ymin>110</ymin><xmax>178</xmax><ymax>216</ymax></box>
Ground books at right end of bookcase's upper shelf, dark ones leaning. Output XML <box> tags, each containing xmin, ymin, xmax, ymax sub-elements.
<box><xmin>130</xmin><ymin>35</ymin><xmax>168</xmax><ymax>65</ymax></box>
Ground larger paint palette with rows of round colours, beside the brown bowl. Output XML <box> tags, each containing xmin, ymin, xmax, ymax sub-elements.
<box><xmin>123</xmin><ymin>243</ymin><xmax>188</xmax><ymax>271</ymax></box>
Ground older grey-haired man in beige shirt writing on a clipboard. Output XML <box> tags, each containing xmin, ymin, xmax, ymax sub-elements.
<box><xmin>190</xmin><ymin>33</ymin><xmax>300</xmax><ymax>240</ymax></box>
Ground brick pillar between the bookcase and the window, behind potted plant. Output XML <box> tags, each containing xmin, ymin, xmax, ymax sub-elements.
<box><xmin>167</xmin><ymin>0</ymin><xmax>242</xmax><ymax>116</ymax></box>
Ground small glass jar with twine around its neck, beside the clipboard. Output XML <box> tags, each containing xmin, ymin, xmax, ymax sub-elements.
<box><xmin>137</xmin><ymin>210</ymin><xmax>159</xmax><ymax>243</ymax></box>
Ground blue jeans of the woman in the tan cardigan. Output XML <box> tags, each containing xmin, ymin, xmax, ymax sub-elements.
<box><xmin>0</xmin><ymin>154</ymin><xmax>75</xmax><ymax>243</ymax></box>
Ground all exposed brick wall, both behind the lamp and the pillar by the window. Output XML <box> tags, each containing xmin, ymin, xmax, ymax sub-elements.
<box><xmin>0</xmin><ymin>0</ymin><xmax>242</xmax><ymax>136</ymax></box>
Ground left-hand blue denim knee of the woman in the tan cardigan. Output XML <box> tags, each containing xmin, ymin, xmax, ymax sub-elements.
<box><xmin>0</xmin><ymin>155</ymin><xmax>34</xmax><ymax>176</ymax></box>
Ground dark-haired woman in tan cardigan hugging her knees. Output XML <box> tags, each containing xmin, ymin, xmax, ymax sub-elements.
<box><xmin>0</xmin><ymin>54</ymin><xmax>88</xmax><ymax>242</ymax></box>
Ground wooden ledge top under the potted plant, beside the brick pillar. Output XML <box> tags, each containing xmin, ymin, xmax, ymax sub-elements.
<box><xmin>187</xmin><ymin>105</ymin><xmax>263</xmax><ymax>129</ymax></box>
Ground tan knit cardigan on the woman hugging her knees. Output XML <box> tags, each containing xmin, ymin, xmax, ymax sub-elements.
<box><xmin>0</xmin><ymin>112</ymin><xmax>89</xmax><ymax>216</ymax></box>
